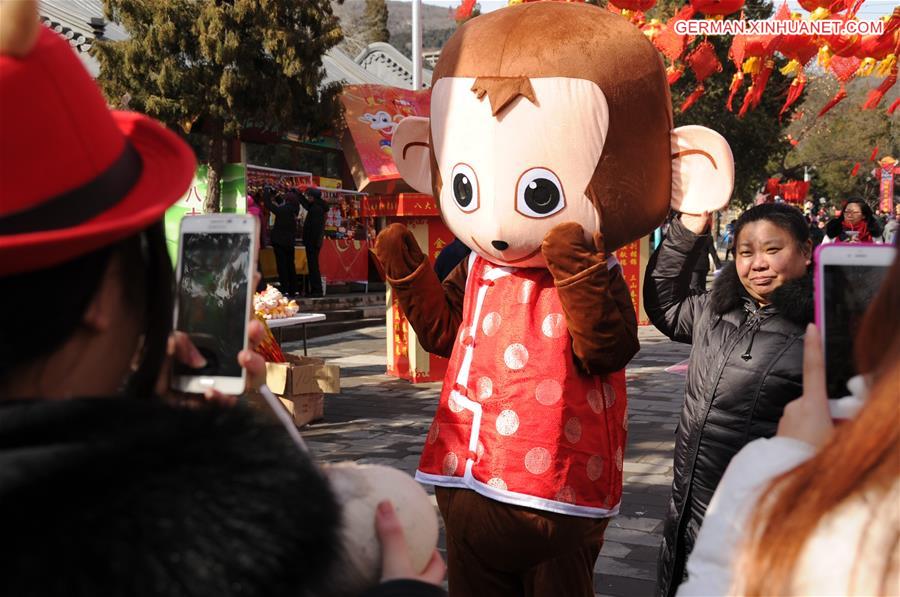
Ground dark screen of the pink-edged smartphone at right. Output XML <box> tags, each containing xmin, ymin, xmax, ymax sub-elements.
<box><xmin>823</xmin><ymin>264</ymin><xmax>888</xmax><ymax>398</ymax></box>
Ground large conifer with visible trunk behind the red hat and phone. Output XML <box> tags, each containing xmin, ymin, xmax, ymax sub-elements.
<box><xmin>92</xmin><ymin>0</ymin><xmax>341</xmax><ymax>212</ymax></box>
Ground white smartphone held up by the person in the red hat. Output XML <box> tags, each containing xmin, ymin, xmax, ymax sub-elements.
<box><xmin>172</xmin><ymin>214</ymin><xmax>259</xmax><ymax>395</ymax></box>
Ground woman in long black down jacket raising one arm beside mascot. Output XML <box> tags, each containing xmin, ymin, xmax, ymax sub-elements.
<box><xmin>644</xmin><ymin>204</ymin><xmax>813</xmax><ymax>597</ymax></box>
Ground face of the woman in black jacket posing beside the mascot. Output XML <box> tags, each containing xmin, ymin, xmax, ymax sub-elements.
<box><xmin>735</xmin><ymin>220</ymin><xmax>812</xmax><ymax>305</ymax></box>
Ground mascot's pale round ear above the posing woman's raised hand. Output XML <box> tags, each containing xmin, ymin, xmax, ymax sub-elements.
<box><xmin>672</xmin><ymin>125</ymin><xmax>734</xmax><ymax>214</ymax></box>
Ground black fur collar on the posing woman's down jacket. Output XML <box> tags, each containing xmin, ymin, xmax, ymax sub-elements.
<box><xmin>710</xmin><ymin>261</ymin><xmax>813</xmax><ymax>326</ymax></box>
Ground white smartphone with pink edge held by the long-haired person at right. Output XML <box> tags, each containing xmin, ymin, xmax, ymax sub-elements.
<box><xmin>815</xmin><ymin>243</ymin><xmax>896</xmax><ymax>398</ymax></box>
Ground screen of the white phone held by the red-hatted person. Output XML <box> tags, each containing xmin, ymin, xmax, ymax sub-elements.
<box><xmin>175</xmin><ymin>232</ymin><xmax>252</xmax><ymax>377</ymax></box>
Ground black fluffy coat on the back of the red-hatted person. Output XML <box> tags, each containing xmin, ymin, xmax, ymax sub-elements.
<box><xmin>0</xmin><ymin>398</ymin><xmax>340</xmax><ymax>597</ymax></box>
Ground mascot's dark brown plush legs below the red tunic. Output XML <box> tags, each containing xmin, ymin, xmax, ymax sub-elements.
<box><xmin>435</xmin><ymin>487</ymin><xmax>609</xmax><ymax>597</ymax></box>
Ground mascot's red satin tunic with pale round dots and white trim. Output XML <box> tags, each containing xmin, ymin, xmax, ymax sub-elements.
<box><xmin>416</xmin><ymin>257</ymin><xmax>627</xmax><ymax>518</ymax></box>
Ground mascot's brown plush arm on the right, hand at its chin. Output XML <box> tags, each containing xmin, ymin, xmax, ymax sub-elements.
<box><xmin>541</xmin><ymin>222</ymin><xmax>640</xmax><ymax>374</ymax></box>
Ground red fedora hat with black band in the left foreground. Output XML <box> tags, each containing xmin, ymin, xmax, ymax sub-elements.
<box><xmin>0</xmin><ymin>11</ymin><xmax>196</xmax><ymax>276</ymax></box>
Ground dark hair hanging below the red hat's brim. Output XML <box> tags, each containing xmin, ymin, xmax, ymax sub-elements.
<box><xmin>0</xmin><ymin>223</ymin><xmax>174</xmax><ymax>396</ymax></box>
